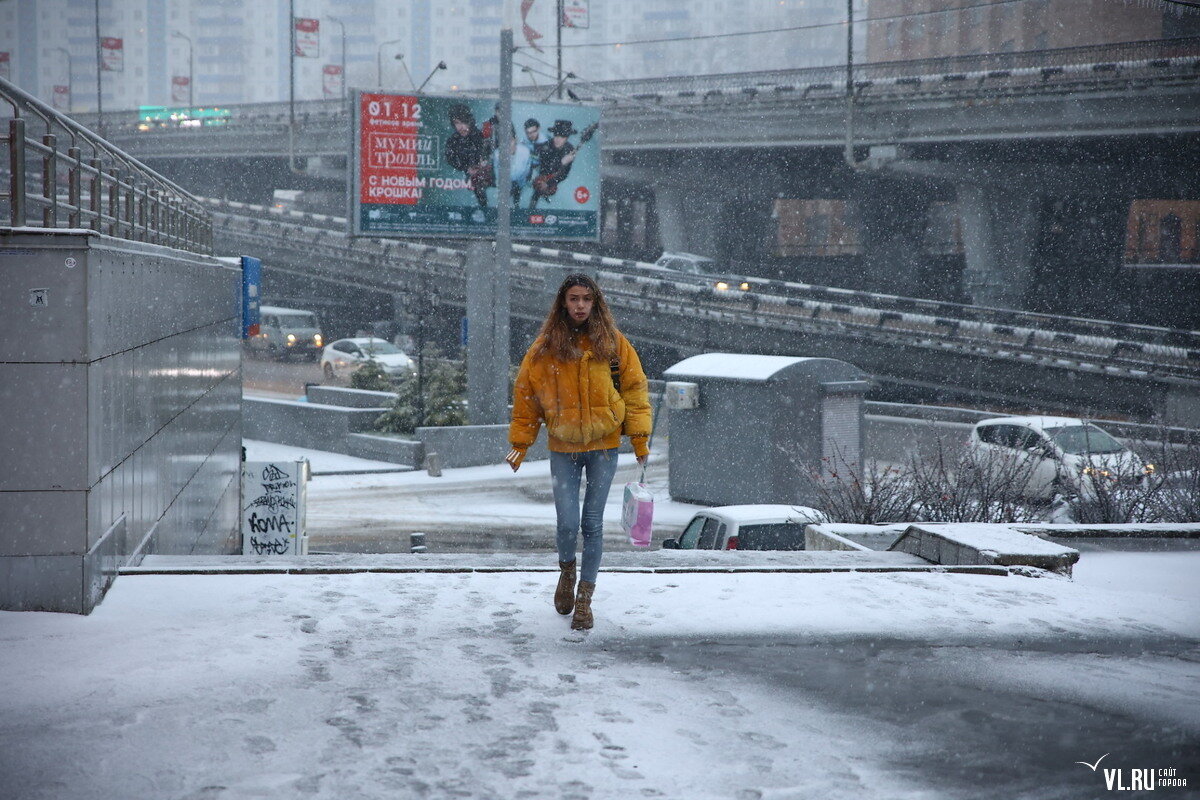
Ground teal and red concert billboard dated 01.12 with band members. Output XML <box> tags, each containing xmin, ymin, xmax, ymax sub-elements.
<box><xmin>350</xmin><ymin>91</ymin><xmax>601</xmax><ymax>241</ymax></box>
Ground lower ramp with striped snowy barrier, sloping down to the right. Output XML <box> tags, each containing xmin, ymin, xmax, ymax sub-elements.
<box><xmin>201</xmin><ymin>200</ymin><xmax>1200</xmax><ymax>422</ymax></box>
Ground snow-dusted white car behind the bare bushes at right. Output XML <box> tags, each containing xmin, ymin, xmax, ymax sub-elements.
<box><xmin>970</xmin><ymin>416</ymin><xmax>1154</xmax><ymax>499</ymax></box>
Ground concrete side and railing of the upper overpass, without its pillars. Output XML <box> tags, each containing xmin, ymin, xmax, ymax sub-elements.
<box><xmin>78</xmin><ymin>38</ymin><xmax>1200</xmax><ymax>161</ymax></box>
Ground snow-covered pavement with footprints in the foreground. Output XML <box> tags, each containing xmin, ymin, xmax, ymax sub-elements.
<box><xmin>0</xmin><ymin>572</ymin><xmax>1200</xmax><ymax>800</ymax></box>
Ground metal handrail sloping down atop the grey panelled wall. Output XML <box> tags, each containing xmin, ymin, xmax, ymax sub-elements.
<box><xmin>0</xmin><ymin>78</ymin><xmax>212</xmax><ymax>254</ymax></box>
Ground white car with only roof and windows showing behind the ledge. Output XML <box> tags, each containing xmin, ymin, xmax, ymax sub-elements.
<box><xmin>662</xmin><ymin>504</ymin><xmax>829</xmax><ymax>551</ymax></box>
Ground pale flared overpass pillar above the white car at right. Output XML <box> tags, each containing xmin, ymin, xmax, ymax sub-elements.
<box><xmin>958</xmin><ymin>182</ymin><xmax>1042</xmax><ymax>308</ymax></box>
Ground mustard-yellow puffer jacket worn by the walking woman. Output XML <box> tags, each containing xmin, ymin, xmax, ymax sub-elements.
<box><xmin>509</xmin><ymin>333</ymin><xmax>650</xmax><ymax>456</ymax></box>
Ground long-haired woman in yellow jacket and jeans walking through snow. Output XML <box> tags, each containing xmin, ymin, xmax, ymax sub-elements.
<box><xmin>505</xmin><ymin>273</ymin><xmax>650</xmax><ymax>631</ymax></box>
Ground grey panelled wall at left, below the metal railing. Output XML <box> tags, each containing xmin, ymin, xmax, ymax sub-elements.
<box><xmin>0</xmin><ymin>230</ymin><xmax>241</xmax><ymax>613</ymax></box>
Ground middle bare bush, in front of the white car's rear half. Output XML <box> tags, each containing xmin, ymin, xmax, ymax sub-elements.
<box><xmin>908</xmin><ymin>437</ymin><xmax>1037</xmax><ymax>523</ymax></box>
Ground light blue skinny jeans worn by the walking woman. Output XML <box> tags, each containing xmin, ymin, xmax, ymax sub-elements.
<box><xmin>550</xmin><ymin>447</ymin><xmax>617</xmax><ymax>583</ymax></box>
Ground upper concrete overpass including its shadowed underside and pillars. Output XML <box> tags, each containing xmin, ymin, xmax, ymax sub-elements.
<box><xmin>82</xmin><ymin>37</ymin><xmax>1200</xmax><ymax>319</ymax></box>
